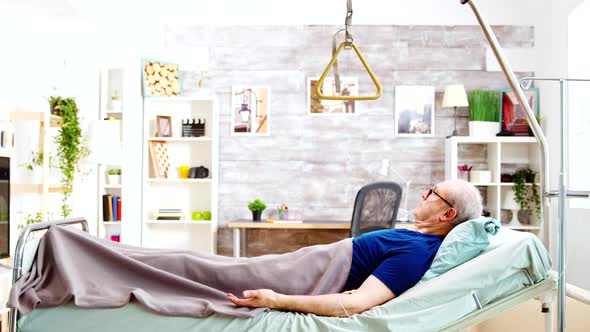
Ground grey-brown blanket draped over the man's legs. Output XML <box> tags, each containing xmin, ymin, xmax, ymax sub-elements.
<box><xmin>8</xmin><ymin>226</ymin><xmax>352</xmax><ymax>318</ymax></box>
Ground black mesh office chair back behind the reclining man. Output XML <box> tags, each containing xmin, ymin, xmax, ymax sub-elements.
<box><xmin>350</xmin><ymin>182</ymin><xmax>402</xmax><ymax>237</ymax></box>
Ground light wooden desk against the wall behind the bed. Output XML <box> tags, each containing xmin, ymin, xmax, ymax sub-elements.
<box><xmin>227</xmin><ymin>220</ymin><xmax>414</xmax><ymax>257</ymax></box>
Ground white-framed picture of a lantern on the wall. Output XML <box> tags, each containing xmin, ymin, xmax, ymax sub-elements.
<box><xmin>231</xmin><ymin>86</ymin><xmax>270</xmax><ymax>136</ymax></box>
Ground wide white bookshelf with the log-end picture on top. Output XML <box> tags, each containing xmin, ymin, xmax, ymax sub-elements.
<box><xmin>141</xmin><ymin>96</ymin><xmax>219</xmax><ymax>253</ymax></box>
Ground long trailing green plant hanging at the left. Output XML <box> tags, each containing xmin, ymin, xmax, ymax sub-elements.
<box><xmin>49</xmin><ymin>97</ymin><xmax>90</xmax><ymax>218</ymax></box>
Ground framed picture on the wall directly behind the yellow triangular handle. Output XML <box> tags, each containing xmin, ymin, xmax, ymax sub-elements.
<box><xmin>307</xmin><ymin>77</ymin><xmax>358</xmax><ymax>116</ymax></box>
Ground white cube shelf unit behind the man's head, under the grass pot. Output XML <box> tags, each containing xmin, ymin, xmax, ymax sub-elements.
<box><xmin>445</xmin><ymin>136</ymin><xmax>542</xmax><ymax>233</ymax></box>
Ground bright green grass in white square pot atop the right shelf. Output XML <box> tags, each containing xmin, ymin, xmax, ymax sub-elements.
<box><xmin>467</xmin><ymin>90</ymin><xmax>500</xmax><ymax>136</ymax></box>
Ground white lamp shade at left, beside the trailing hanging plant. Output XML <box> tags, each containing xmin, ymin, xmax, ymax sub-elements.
<box><xmin>87</xmin><ymin>120</ymin><xmax>121</xmax><ymax>165</ymax></box>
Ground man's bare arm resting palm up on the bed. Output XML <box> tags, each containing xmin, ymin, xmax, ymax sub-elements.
<box><xmin>227</xmin><ymin>276</ymin><xmax>395</xmax><ymax>317</ymax></box>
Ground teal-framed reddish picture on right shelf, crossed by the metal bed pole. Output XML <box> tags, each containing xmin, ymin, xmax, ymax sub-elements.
<box><xmin>500</xmin><ymin>88</ymin><xmax>539</xmax><ymax>136</ymax></box>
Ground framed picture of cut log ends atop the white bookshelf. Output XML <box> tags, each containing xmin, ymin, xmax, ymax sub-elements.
<box><xmin>141</xmin><ymin>59</ymin><xmax>182</xmax><ymax>97</ymax></box>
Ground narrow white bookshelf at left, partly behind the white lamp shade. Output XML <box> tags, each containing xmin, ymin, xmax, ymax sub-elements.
<box><xmin>97</xmin><ymin>68</ymin><xmax>126</xmax><ymax>242</ymax></box>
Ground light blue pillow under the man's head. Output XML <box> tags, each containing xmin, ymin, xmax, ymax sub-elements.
<box><xmin>420</xmin><ymin>217</ymin><xmax>500</xmax><ymax>282</ymax></box>
